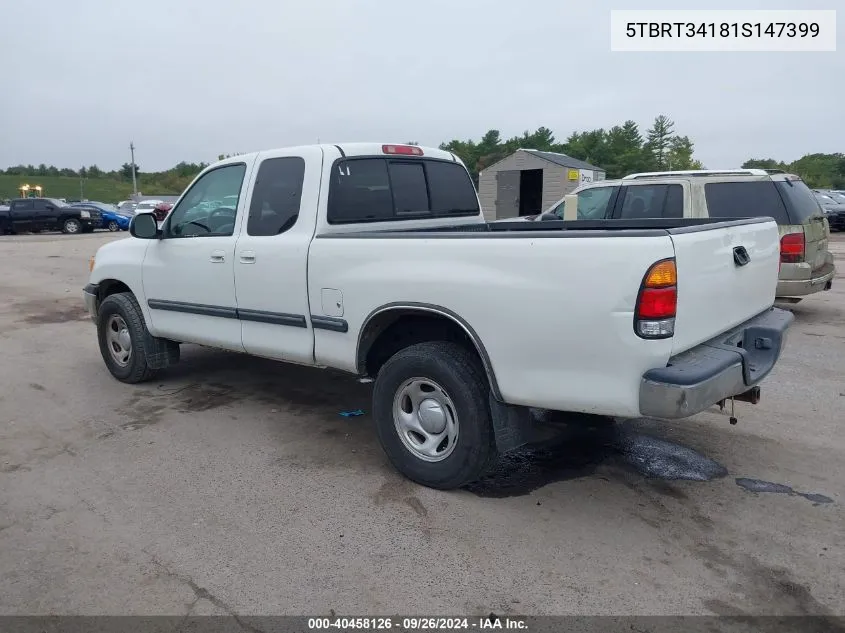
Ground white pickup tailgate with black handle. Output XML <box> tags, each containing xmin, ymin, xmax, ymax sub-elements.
<box><xmin>669</xmin><ymin>219</ymin><xmax>780</xmax><ymax>354</ymax></box>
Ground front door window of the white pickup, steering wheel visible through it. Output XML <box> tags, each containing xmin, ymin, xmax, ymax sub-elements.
<box><xmin>165</xmin><ymin>163</ymin><xmax>246</xmax><ymax>237</ymax></box>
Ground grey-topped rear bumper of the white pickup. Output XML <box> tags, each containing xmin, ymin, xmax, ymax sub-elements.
<box><xmin>640</xmin><ymin>308</ymin><xmax>794</xmax><ymax>419</ymax></box>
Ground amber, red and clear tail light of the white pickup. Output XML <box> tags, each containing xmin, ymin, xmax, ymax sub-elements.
<box><xmin>634</xmin><ymin>258</ymin><xmax>678</xmax><ymax>339</ymax></box>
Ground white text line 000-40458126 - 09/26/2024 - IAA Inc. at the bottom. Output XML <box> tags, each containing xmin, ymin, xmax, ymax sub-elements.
<box><xmin>308</xmin><ymin>615</ymin><xmax>528</xmax><ymax>631</ymax></box>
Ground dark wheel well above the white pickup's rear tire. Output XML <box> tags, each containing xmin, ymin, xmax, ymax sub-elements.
<box><xmin>358</xmin><ymin>308</ymin><xmax>500</xmax><ymax>398</ymax></box>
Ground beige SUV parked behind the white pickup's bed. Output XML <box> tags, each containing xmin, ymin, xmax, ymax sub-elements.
<box><xmin>535</xmin><ymin>169</ymin><xmax>836</xmax><ymax>302</ymax></box>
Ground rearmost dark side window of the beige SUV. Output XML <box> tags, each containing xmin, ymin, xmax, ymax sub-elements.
<box><xmin>704</xmin><ymin>180</ymin><xmax>792</xmax><ymax>224</ymax></box>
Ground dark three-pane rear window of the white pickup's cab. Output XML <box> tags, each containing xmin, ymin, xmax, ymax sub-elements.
<box><xmin>328</xmin><ymin>158</ymin><xmax>479</xmax><ymax>224</ymax></box>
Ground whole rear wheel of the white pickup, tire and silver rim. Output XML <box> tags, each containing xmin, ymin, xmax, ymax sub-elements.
<box><xmin>373</xmin><ymin>342</ymin><xmax>497</xmax><ymax>490</ymax></box>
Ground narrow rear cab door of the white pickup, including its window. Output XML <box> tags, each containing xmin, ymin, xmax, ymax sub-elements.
<box><xmin>235</xmin><ymin>147</ymin><xmax>323</xmax><ymax>364</ymax></box>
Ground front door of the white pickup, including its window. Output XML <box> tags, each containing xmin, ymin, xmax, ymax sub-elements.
<box><xmin>143</xmin><ymin>161</ymin><xmax>252</xmax><ymax>351</ymax></box>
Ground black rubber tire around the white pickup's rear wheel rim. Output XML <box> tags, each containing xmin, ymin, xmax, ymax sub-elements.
<box><xmin>373</xmin><ymin>341</ymin><xmax>497</xmax><ymax>490</ymax></box>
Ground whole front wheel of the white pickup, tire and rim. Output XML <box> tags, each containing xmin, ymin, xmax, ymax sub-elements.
<box><xmin>97</xmin><ymin>293</ymin><xmax>156</xmax><ymax>384</ymax></box>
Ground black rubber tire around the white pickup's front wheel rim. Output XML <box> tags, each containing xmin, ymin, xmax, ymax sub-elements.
<box><xmin>97</xmin><ymin>292</ymin><xmax>158</xmax><ymax>385</ymax></box>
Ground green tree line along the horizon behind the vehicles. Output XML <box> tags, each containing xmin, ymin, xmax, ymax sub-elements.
<box><xmin>0</xmin><ymin>114</ymin><xmax>845</xmax><ymax>194</ymax></box>
